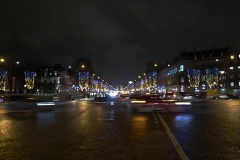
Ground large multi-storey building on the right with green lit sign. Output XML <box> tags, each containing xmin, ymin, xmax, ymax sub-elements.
<box><xmin>158</xmin><ymin>46</ymin><xmax>240</xmax><ymax>93</ymax></box>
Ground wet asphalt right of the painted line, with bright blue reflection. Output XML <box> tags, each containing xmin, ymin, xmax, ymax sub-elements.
<box><xmin>160</xmin><ymin>100</ymin><xmax>240</xmax><ymax>160</ymax></box>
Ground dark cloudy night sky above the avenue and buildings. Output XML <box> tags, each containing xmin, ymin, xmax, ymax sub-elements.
<box><xmin>0</xmin><ymin>0</ymin><xmax>240</xmax><ymax>85</ymax></box>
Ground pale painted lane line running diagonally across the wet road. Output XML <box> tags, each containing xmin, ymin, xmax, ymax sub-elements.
<box><xmin>157</xmin><ymin>113</ymin><xmax>189</xmax><ymax>160</ymax></box>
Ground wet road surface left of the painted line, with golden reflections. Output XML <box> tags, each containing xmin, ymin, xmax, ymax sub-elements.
<box><xmin>0</xmin><ymin>101</ymin><xmax>180</xmax><ymax>160</ymax></box>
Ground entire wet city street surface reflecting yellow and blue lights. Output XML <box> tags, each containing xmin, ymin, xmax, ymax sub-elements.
<box><xmin>0</xmin><ymin>100</ymin><xmax>240</xmax><ymax>160</ymax></box>
